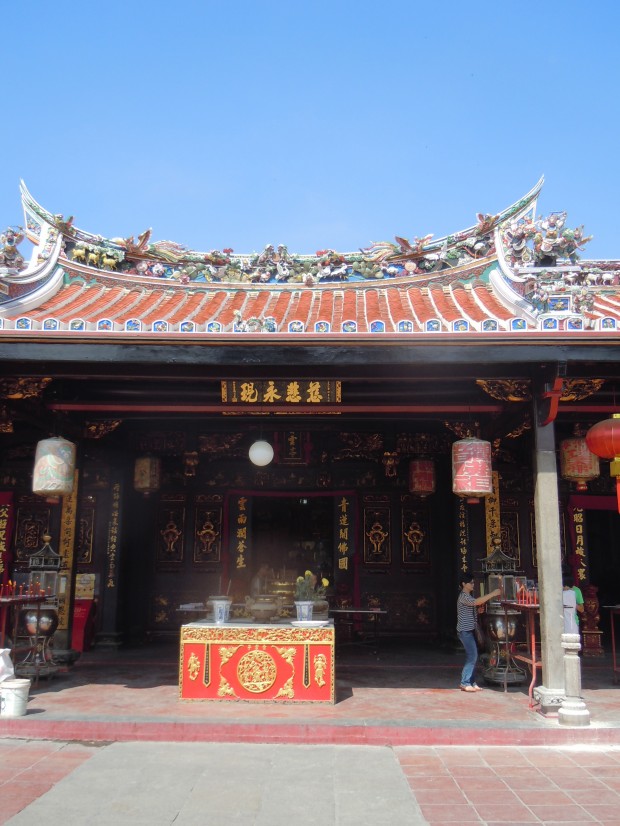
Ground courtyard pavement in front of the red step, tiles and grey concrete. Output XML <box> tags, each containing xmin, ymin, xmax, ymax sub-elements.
<box><xmin>0</xmin><ymin>739</ymin><xmax>620</xmax><ymax>826</ymax></box>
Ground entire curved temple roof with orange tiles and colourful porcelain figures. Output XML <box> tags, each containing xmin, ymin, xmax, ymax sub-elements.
<box><xmin>0</xmin><ymin>178</ymin><xmax>620</xmax><ymax>338</ymax></box>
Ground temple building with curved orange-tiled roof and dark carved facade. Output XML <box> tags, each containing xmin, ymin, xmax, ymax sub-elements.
<box><xmin>0</xmin><ymin>179</ymin><xmax>620</xmax><ymax>703</ymax></box>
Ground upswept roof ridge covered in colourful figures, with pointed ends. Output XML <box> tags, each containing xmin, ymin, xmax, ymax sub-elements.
<box><xmin>15</xmin><ymin>178</ymin><xmax>543</xmax><ymax>290</ymax></box>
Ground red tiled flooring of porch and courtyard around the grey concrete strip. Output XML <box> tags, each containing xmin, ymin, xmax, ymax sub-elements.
<box><xmin>0</xmin><ymin>646</ymin><xmax>620</xmax><ymax>826</ymax></box>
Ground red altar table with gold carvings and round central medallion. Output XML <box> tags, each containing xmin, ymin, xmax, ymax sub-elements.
<box><xmin>179</xmin><ymin>620</ymin><xmax>336</xmax><ymax>704</ymax></box>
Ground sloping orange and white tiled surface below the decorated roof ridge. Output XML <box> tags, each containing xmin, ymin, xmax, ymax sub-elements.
<box><xmin>2</xmin><ymin>264</ymin><xmax>620</xmax><ymax>334</ymax></box>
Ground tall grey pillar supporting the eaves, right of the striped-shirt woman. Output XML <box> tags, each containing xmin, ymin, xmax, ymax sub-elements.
<box><xmin>533</xmin><ymin>394</ymin><xmax>564</xmax><ymax>713</ymax></box>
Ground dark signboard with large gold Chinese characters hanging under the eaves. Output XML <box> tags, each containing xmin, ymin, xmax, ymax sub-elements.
<box><xmin>221</xmin><ymin>379</ymin><xmax>342</xmax><ymax>410</ymax></box>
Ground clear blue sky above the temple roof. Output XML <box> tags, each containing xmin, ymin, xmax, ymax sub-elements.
<box><xmin>0</xmin><ymin>0</ymin><xmax>620</xmax><ymax>258</ymax></box>
